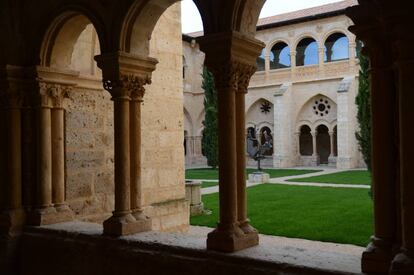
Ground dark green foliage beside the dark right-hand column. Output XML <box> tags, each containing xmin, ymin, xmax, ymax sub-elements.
<box><xmin>355</xmin><ymin>42</ymin><xmax>371</xmax><ymax>172</ymax></box>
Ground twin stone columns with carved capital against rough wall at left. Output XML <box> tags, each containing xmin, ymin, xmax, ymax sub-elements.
<box><xmin>28</xmin><ymin>79</ymin><xmax>73</xmax><ymax>226</ymax></box>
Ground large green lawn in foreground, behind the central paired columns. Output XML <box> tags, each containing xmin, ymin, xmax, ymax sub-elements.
<box><xmin>191</xmin><ymin>184</ymin><xmax>373</xmax><ymax>246</ymax></box>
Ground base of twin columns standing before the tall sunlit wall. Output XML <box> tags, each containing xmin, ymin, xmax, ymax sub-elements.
<box><xmin>103</xmin><ymin>214</ymin><xmax>151</xmax><ymax>237</ymax></box>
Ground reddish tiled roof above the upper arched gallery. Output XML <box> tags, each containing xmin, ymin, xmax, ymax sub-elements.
<box><xmin>185</xmin><ymin>0</ymin><xmax>358</xmax><ymax>38</ymax></box>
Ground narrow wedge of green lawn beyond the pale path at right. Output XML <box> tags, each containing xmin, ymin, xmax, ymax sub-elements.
<box><xmin>288</xmin><ymin>171</ymin><xmax>371</xmax><ymax>185</ymax></box>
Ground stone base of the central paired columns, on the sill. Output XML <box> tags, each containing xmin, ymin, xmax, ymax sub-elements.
<box><xmin>207</xmin><ymin>225</ymin><xmax>259</xmax><ymax>252</ymax></box>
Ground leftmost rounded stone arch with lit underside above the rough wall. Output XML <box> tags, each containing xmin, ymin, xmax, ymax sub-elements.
<box><xmin>40</xmin><ymin>11</ymin><xmax>103</xmax><ymax>70</ymax></box>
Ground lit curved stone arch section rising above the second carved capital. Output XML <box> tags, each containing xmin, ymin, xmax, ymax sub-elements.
<box><xmin>120</xmin><ymin>0</ymin><xmax>179</xmax><ymax>57</ymax></box>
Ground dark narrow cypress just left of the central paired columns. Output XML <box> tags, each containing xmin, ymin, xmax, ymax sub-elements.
<box><xmin>202</xmin><ymin>67</ymin><xmax>219</xmax><ymax>168</ymax></box>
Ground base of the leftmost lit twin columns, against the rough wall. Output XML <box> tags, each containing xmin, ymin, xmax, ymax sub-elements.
<box><xmin>27</xmin><ymin>206</ymin><xmax>73</xmax><ymax>226</ymax></box>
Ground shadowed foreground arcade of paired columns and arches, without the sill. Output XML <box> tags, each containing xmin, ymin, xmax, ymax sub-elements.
<box><xmin>0</xmin><ymin>0</ymin><xmax>414</xmax><ymax>274</ymax></box>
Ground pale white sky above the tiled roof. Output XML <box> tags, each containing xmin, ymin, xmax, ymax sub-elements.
<box><xmin>181</xmin><ymin>0</ymin><xmax>341</xmax><ymax>33</ymax></box>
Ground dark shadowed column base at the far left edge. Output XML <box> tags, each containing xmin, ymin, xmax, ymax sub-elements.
<box><xmin>0</xmin><ymin>209</ymin><xmax>26</xmax><ymax>236</ymax></box>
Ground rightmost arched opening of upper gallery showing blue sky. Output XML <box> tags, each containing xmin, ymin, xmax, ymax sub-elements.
<box><xmin>325</xmin><ymin>33</ymin><xmax>349</xmax><ymax>62</ymax></box>
